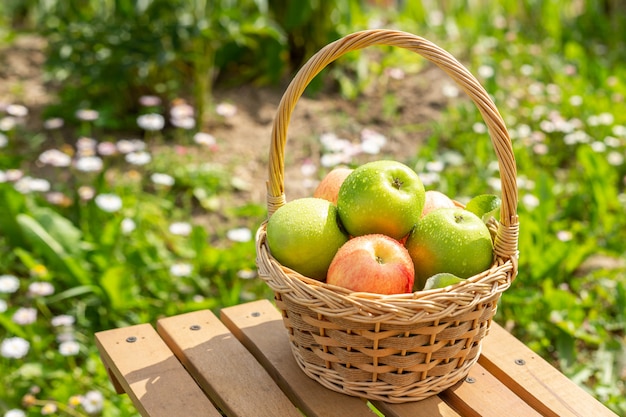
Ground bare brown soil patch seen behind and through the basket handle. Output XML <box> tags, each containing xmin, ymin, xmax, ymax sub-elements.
<box><xmin>211</xmin><ymin>67</ymin><xmax>448</xmax><ymax>206</ymax></box>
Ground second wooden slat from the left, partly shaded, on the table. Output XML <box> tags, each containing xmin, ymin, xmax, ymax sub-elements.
<box><xmin>157</xmin><ymin>310</ymin><xmax>302</xmax><ymax>417</ymax></box>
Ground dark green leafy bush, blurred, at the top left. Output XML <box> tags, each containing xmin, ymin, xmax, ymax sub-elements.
<box><xmin>38</xmin><ymin>0</ymin><xmax>285</xmax><ymax>128</ymax></box>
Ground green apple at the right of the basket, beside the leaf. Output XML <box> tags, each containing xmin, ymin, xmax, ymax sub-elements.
<box><xmin>406</xmin><ymin>207</ymin><xmax>493</xmax><ymax>290</ymax></box>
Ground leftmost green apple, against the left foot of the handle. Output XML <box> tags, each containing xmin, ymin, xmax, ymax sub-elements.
<box><xmin>266</xmin><ymin>197</ymin><xmax>348</xmax><ymax>281</ymax></box>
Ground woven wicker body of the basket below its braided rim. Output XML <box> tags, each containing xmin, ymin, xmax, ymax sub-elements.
<box><xmin>275</xmin><ymin>293</ymin><xmax>499</xmax><ymax>403</ymax></box>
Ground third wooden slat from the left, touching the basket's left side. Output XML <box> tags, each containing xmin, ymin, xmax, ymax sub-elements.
<box><xmin>220</xmin><ymin>300</ymin><xmax>374</xmax><ymax>417</ymax></box>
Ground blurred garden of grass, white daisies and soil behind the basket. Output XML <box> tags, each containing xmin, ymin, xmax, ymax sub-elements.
<box><xmin>0</xmin><ymin>0</ymin><xmax>626</xmax><ymax>417</ymax></box>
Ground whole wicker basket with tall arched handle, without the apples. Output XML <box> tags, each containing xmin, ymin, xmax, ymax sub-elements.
<box><xmin>257</xmin><ymin>30</ymin><xmax>518</xmax><ymax>403</ymax></box>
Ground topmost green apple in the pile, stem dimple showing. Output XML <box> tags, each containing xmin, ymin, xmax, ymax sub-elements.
<box><xmin>337</xmin><ymin>160</ymin><xmax>425</xmax><ymax>240</ymax></box>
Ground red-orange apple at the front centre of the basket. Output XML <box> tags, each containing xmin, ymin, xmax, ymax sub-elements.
<box><xmin>326</xmin><ymin>234</ymin><xmax>415</xmax><ymax>294</ymax></box>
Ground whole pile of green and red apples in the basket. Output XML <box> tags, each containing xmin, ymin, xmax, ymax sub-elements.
<box><xmin>267</xmin><ymin>160</ymin><xmax>500</xmax><ymax>294</ymax></box>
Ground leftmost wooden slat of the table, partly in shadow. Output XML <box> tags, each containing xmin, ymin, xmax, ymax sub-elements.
<box><xmin>95</xmin><ymin>324</ymin><xmax>220</xmax><ymax>417</ymax></box>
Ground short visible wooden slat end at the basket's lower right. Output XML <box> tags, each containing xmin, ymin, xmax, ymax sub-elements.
<box><xmin>441</xmin><ymin>364</ymin><xmax>541</xmax><ymax>417</ymax></box>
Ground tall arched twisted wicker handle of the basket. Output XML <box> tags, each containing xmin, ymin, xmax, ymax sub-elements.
<box><xmin>267</xmin><ymin>29</ymin><xmax>518</xmax><ymax>269</ymax></box>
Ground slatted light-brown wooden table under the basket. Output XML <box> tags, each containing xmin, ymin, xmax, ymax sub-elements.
<box><xmin>96</xmin><ymin>300</ymin><xmax>615</xmax><ymax>417</ymax></box>
